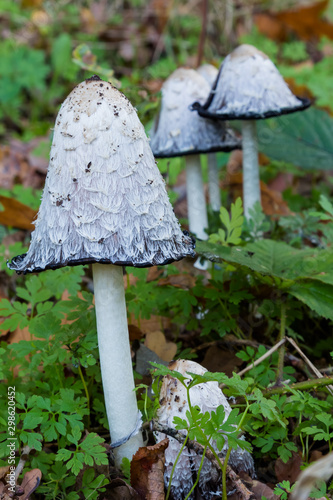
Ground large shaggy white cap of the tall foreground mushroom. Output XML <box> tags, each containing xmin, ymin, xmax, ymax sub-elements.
<box><xmin>8</xmin><ymin>76</ymin><xmax>194</xmax><ymax>273</ymax></box>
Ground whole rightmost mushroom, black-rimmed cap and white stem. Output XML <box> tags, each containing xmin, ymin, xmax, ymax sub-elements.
<box><xmin>192</xmin><ymin>45</ymin><xmax>311</xmax><ymax>218</ymax></box>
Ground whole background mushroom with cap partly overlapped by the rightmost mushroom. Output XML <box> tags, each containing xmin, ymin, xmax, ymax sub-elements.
<box><xmin>151</xmin><ymin>68</ymin><xmax>239</xmax><ymax>240</ymax></box>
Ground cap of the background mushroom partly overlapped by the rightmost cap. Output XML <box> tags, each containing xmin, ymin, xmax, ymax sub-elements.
<box><xmin>150</xmin><ymin>68</ymin><xmax>240</xmax><ymax>158</ymax></box>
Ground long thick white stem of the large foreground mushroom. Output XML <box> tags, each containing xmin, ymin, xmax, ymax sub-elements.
<box><xmin>93</xmin><ymin>264</ymin><xmax>143</xmax><ymax>465</ymax></box>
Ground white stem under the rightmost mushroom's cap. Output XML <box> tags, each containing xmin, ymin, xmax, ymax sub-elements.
<box><xmin>242</xmin><ymin>120</ymin><xmax>261</xmax><ymax>219</ymax></box>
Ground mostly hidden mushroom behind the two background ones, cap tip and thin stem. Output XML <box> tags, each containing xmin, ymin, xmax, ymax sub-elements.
<box><xmin>197</xmin><ymin>64</ymin><xmax>221</xmax><ymax>212</ymax></box>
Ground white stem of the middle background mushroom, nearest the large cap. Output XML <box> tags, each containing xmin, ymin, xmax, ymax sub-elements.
<box><xmin>186</xmin><ymin>155</ymin><xmax>208</xmax><ymax>240</ymax></box>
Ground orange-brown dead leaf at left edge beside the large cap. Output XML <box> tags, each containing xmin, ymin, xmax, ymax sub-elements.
<box><xmin>0</xmin><ymin>195</ymin><xmax>37</xmax><ymax>231</ymax></box>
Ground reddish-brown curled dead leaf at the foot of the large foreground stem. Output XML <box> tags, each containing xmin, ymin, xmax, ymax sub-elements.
<box><xmin>131</xmin><ymin>438</ymin><xmax>169</xmax><ymax>500</ymax></box>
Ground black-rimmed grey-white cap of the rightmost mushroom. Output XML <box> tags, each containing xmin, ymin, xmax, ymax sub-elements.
<box><xmin>193</xmin><ymin>45</ymin><xmax>311</xmax><ymax>120</ymax></box>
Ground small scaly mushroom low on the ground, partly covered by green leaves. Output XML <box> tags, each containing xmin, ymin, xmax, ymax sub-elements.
<box><xmin>156</xmin><ymin>359</ymin><xmax>254</xmax><ymax>500</ymax></box>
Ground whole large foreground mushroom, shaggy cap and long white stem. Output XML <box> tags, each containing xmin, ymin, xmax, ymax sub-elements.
<box><xmin>9</xmin><ymin>76</ymin><xmax>194</xmax><ymax>464</ymax></box>
